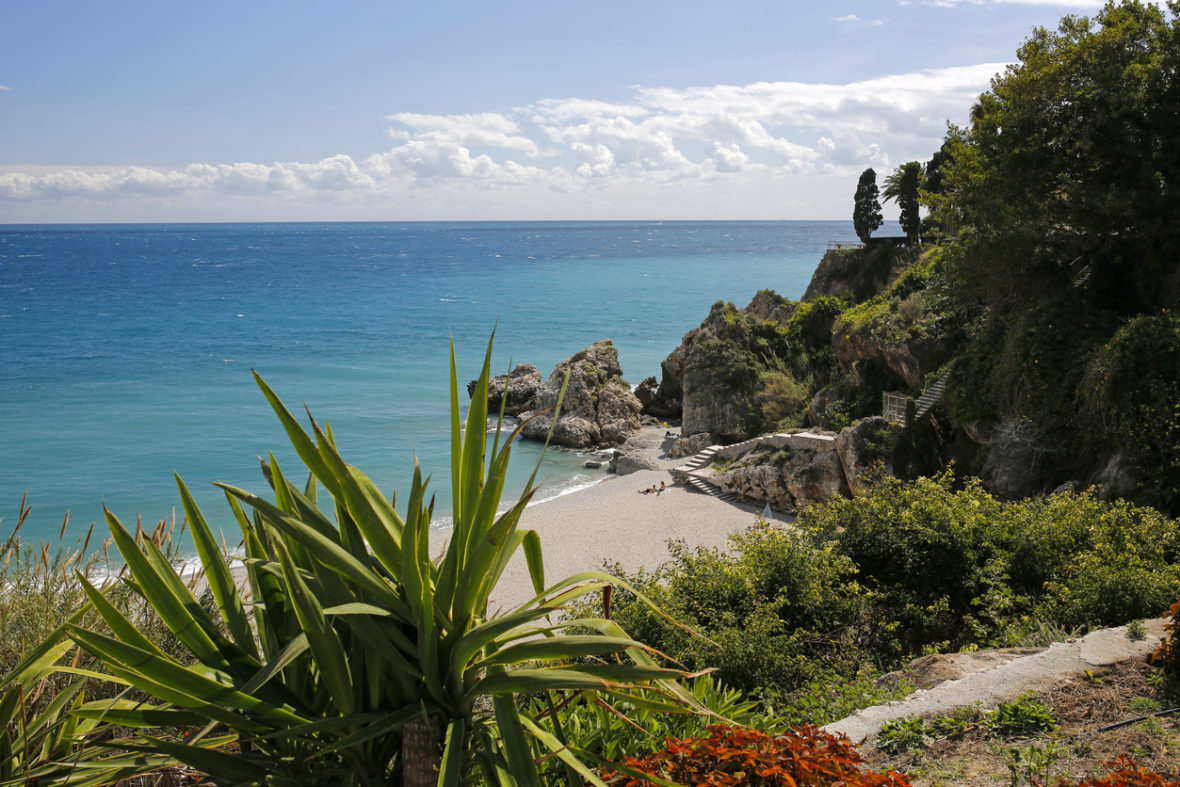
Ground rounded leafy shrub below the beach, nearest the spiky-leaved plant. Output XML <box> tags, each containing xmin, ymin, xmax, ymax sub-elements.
<box><xmin>599</xmin><ymin>527</ymin><xmax>861</xmax><ymax>694</ymax></box>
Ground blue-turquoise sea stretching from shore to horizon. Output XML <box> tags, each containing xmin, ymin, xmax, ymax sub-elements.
<box><xmin>0</xmin><ymin>222</ymin><xmax>868</xmax><ymax>554</ymax></box>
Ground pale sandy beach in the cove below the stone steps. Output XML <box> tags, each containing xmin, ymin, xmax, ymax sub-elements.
<box><xmin>492</xmin><ymin>427</ymin><xmax>761</xmax><ymax>609</ymax></box>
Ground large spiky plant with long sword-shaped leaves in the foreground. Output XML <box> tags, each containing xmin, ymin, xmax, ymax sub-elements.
<box><xmin>68</xmin><ymin>342</ymin><xmax>693</xmax><ymax>787</ymax></box>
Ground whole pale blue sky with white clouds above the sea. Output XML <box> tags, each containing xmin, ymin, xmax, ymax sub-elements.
<box><xmin>0</xmin><ymin>0</ymin><xmax>1101</xmax><ymax>223</ymax></box>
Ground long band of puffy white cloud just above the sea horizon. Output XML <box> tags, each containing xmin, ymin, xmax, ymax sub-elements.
<box><xmin>0</xmin><ymin>64</ymin><xmax>1004</xmax><ymax>218</ymax></box>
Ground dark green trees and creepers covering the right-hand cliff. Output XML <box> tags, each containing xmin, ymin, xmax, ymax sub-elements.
<box><xmin>802</xmin><ymin>0</ymin><xmax>1180</xmax><ymax>516</ymax></box>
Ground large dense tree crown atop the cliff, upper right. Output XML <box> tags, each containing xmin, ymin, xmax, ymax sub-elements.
<box><xmin>948</xmin><ymin>0</ymin><xmax>1180</xmax><ymax>314</ymax></box>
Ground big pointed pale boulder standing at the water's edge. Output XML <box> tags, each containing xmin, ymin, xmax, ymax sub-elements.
<box><xmin>522</xmin><ymin>339</ymin><xmax>640</xmax><ymax>448</ymax></box>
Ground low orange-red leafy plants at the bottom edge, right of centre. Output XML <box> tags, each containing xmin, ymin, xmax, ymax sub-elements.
<box><xmin>604</xmin><ymin>724</ymin><xmax>910</xmax><ymax>787</ymax></box>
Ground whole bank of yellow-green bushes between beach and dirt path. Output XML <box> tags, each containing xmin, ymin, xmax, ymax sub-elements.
<box><xmin>599</xmin><ymin>472</ymin><xmax>1180</xmax><ymax>723</ymax></box>
